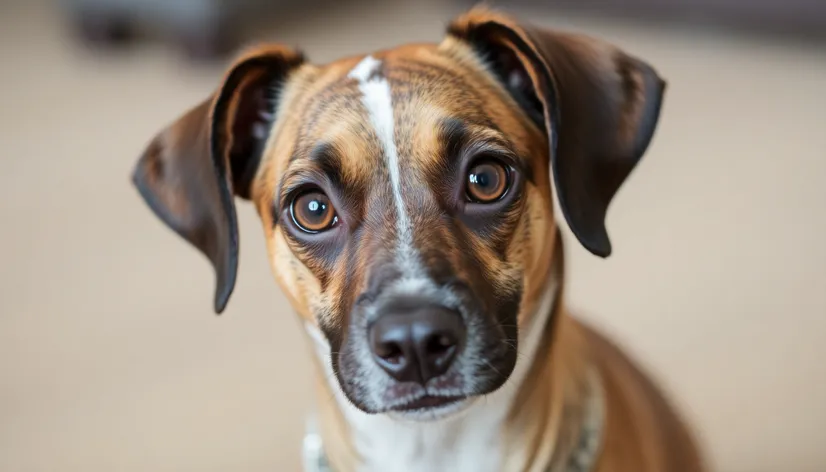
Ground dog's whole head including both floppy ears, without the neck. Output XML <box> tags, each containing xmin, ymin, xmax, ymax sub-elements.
<box><xmin>135</xmin><ymin>10</ymin><xmax>663</xmax><ymax>414</ymax></box>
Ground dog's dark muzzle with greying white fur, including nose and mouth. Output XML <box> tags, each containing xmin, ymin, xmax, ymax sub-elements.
<box><xmin>331</xmin><ymin>260</ymin><xmax>518</xmax><ymax>416</ymax></box>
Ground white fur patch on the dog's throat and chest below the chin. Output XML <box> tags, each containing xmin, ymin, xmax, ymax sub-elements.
<box><xmin>306</xmin><ymin>280</ymin><xmax>558</xmax><ymax>472</ymax></box>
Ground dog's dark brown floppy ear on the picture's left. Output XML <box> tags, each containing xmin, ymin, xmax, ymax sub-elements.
<box><xmin>132</xmin><ymin>46</ymin><xmax>303</xmax><ymax>313</ymax></box>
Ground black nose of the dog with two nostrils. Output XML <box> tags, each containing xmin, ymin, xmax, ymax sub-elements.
<box><xmin>369</xmin><ymin>305</ymin><xmax>465</xmax><ymax>385</ymax></box>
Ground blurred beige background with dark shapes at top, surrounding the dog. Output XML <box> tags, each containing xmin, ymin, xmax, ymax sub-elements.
<box><xmin>0</xmin><ymin>0</ymin><xmax>826</xmax><ymax>472</ymax></box>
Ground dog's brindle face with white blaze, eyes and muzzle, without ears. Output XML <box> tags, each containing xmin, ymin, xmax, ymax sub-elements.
<box><xmin>260</xmin><ymin>43</ymin><xmax>553</xmax><ymax>412</ymax></box>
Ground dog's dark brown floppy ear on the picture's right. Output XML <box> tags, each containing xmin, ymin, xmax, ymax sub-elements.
<box><xmin>448</xmin><ymin>8</ymin><xmax>665</xmax><ymax>257</ymax></box>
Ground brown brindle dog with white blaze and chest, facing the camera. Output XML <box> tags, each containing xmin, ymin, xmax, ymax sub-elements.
<box><xmin>133</xmin><ymin>7</ymin><xmax>705</xmax><ymax>472</ymax></box>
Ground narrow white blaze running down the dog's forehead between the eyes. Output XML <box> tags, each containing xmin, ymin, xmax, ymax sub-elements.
<box><xmin>347</xmin><ymin>56</ymin><xmax>418</xmax><ymax>275</ymax></box>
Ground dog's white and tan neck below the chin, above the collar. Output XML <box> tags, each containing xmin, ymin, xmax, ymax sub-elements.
<box><xmin>302</xmin><ymin>242</ymin><xmax>586</xmax><ymax>472</ymax></box>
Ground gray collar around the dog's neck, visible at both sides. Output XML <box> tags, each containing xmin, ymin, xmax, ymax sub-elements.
<box><xmin>302</xmin><ymin>371</ymin><xmax>605</xmax><ymax>472</ymax></box>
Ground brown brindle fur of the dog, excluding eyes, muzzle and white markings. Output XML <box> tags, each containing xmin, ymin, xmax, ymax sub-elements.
<box><xmin>129</xmin><ymin>5</ymin><xmax>702</xmax><ymax>472</ymax></box>
